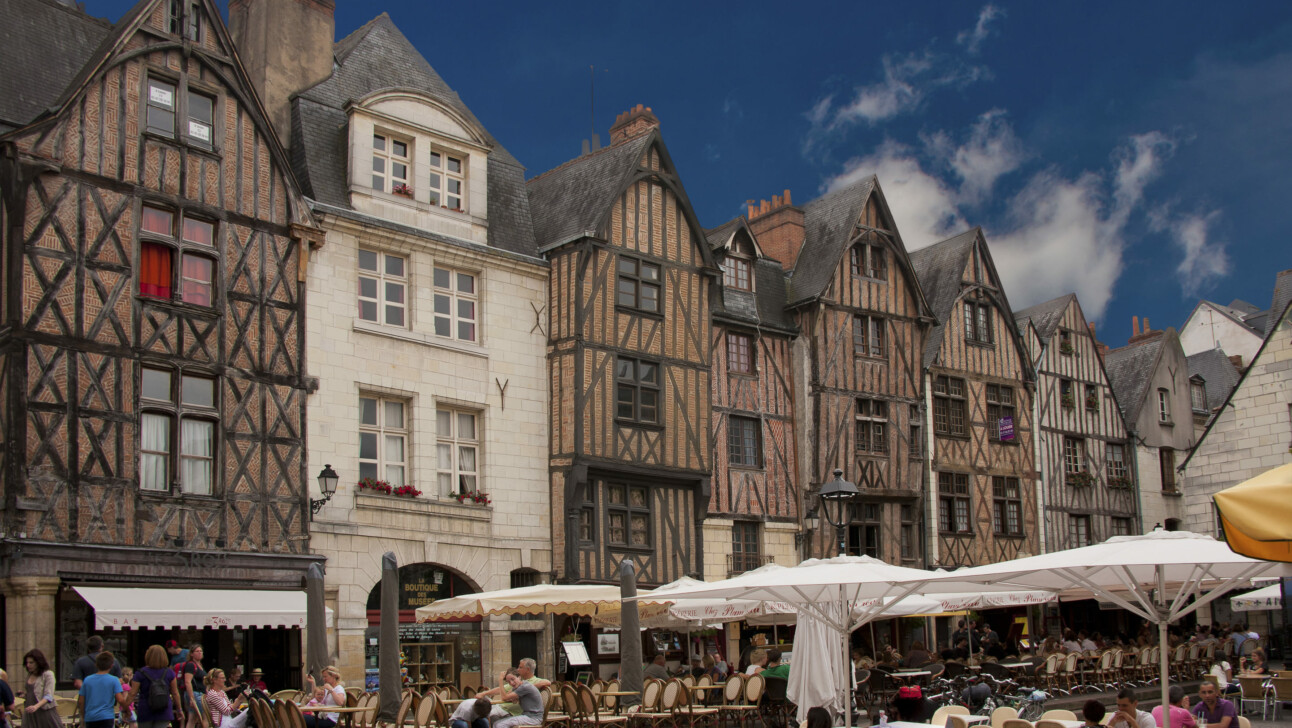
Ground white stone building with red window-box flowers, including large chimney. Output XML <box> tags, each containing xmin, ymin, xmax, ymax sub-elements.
<box><xmin>230</xmin><ymin>0</ymin><xmax>552</xmax><ymax>692</ymax></box>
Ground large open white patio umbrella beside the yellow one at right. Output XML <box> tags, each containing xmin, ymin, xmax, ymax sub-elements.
<box><xmin>926</xmin><ymin>530</ymin><xmax>1292</xmax><ymax>728</ymax></box>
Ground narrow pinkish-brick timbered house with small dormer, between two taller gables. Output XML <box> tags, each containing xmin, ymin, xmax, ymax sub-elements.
<box><xmin>704</xmin><ymin>217</ymin><xmax>802</xmax><ymax>578</ymax></box>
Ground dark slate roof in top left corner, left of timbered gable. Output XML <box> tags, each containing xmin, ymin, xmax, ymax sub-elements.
<box><xmin>0</xmin><ymin>0</ymin><xmax>111</xmax><ymax>133</ymax></box>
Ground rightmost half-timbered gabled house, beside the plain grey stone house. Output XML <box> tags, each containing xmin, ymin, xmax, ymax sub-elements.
<box><xmin>1014</xmin><ymin>294</ymin><xmax>1140</xmax><ymax>551</ymax></box>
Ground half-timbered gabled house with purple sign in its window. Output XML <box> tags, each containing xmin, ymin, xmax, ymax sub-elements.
<box><xmin>911</xmin><ymin>228</ymin><xmax>1037</xmax><ymax>566</ymax></box>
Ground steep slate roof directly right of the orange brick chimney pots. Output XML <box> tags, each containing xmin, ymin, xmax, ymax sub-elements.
<box><xmin>789</xmin><ymin>175</ymin><xmax>877</xmax><ymax>305</ymax></box>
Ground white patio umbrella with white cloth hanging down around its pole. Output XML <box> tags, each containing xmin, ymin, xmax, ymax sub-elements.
<box><xmin>630</xmin><ymin>556</ymin><xmax>1017</xmax><ymax>727</ymax></box>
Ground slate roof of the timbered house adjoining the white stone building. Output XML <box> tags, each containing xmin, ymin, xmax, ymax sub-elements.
<box><xmin>526</xmin><ymin>132</ymin><xmax>658</xmax><ymax>251</ymax></box>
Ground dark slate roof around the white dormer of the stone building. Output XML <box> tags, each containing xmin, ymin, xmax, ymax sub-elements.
<box><xmin>292</xmin><ymin>13</ymin><xmax>537</xmax><ymax>256</ymax></box>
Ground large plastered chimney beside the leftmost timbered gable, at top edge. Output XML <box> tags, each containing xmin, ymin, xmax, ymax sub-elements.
<box><xmin>229</xmin><ymin>0</ymin><xmax>336</xmax><ymax>149</ymax></box>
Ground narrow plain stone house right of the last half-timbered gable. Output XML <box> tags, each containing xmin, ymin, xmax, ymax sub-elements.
<box><xmin>1105</xmin><ymin>317</ymin><xmax>1205</xmax><ymax>533</ymax></box>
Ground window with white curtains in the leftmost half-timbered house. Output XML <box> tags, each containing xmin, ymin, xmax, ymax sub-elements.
<box><xmin>140</xmin><ymin>367</ymin><xmax>220</xmax><ymax>495</ymax></box>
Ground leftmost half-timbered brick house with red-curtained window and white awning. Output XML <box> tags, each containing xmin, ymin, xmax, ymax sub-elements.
<box><xmin>0</xmin><ymin>0</ymin><xmax>319</xmax><ymax>679</ymax></box>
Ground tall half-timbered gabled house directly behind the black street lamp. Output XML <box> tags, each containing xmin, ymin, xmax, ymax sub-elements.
<box><xmin>770</xmin><ymin>177</ymin><xmax>933</xmax><ymax>564</ymax></box>
